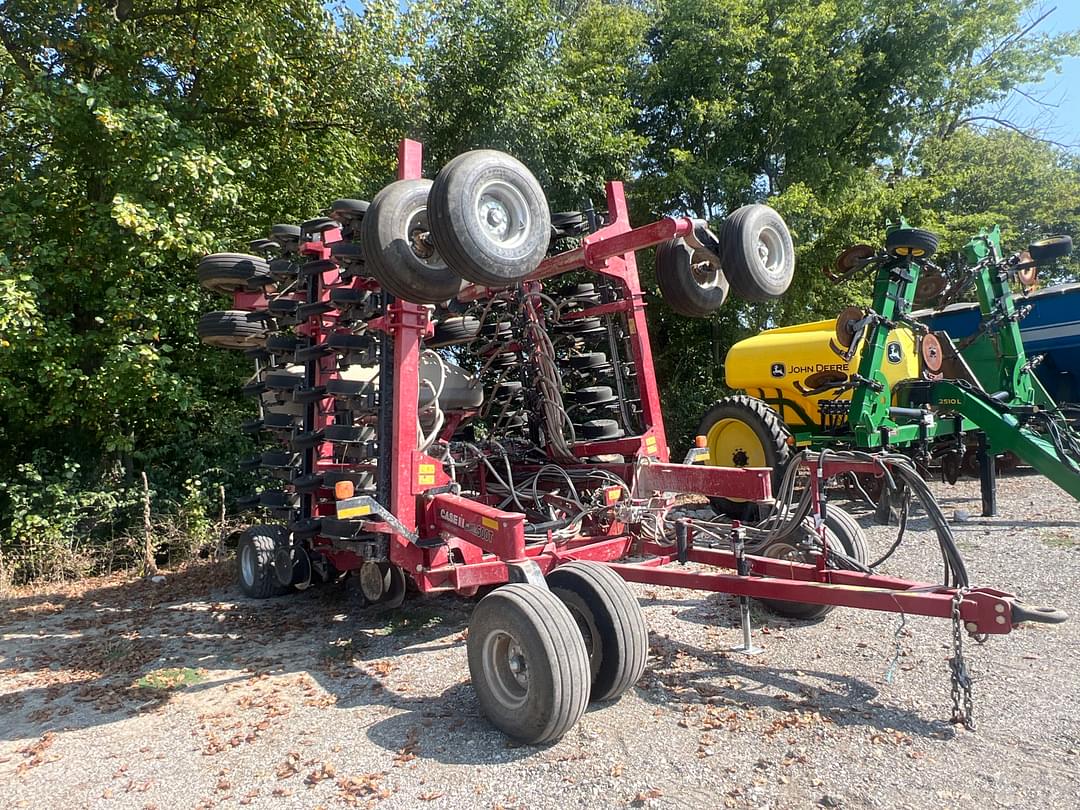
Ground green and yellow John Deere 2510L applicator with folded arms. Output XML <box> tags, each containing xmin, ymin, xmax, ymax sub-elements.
<box><xmin>698</xmin><ymin>221</ymin><xmax>1080</xmax><ymax>514</ymax></box>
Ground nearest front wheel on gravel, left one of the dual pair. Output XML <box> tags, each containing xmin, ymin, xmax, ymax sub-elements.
<box><xmin>467</xmin><ymin>583</ymin><xmax>591</xmax><ymax>744</ymax></box>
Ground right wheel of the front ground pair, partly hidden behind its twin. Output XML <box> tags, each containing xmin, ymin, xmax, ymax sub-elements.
<box><xmin>548</xmin><ymin>562</ymin><xmax>649</xmax><ymax>701</ymax></box>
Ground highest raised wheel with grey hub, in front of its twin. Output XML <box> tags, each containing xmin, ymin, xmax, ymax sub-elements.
<box><xmin>428</xmin><ymin>149</ymin><xmax>551</xmax><ymax>287</ymax></box>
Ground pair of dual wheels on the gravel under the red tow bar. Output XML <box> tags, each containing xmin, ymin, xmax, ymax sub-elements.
<box><xmin>468</xmin><ymin>562</ymin><xmax>649</xmax><ymax>744</ymax></box>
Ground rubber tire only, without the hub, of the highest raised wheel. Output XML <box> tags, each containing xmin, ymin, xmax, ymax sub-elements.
<box><xmin>428</xmin><ymin>149</ymin><xmax>551</xmax><ymax>287</ymax></box>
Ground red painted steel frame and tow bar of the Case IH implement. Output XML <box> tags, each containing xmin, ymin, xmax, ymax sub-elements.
<box><xmin>237</xmin><ymin>140</ymin><xmax>1045</xmax><ymax>634</ymax></box>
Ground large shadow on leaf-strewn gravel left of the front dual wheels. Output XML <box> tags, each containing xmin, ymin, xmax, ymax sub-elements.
<box><xmin>0</xmin><ymin>562</ymin><xmax>481</xmax><ymax>761</ymax></box>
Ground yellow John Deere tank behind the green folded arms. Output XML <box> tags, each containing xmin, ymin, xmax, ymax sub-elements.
<box><xmin>724</xmin><ymin>319</ymin><xmax>919</xmax><ymax>428</ymax></box>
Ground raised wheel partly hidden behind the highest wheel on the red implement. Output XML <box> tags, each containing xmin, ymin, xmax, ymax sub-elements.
<box><xmin>362</xmin><ymin>180</ymin><xmax>461</xmax><ymax>303</ymax></box>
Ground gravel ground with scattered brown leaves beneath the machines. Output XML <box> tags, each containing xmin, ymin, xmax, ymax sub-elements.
<box><xmin>0</xmin><ymin>475</ymin><xmax>1080</xmax><ymax>809</ymax></box>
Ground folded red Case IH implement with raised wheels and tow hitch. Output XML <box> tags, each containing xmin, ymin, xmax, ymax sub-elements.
<box><xmin>200</xmin><ymin>141</ymin><xmax>1064</xmax><ymax>742</ymax></box>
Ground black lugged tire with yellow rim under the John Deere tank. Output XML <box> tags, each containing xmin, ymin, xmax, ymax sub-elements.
<box><xmin>698</xmin><ymin>394</ymin><xmax>792</xmax><ymax>521</ymax></box>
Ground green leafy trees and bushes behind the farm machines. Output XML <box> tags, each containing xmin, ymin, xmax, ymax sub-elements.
<box><xmin>0</xmin><ymin>0</ymin><xmax>1080</xmax><ymax>579</ymax></box>
